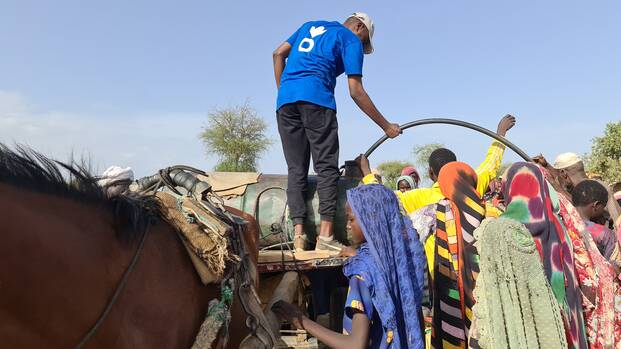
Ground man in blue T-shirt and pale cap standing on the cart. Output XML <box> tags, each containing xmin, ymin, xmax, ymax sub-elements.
<box><xmin>274</xmin><ymin>12</ymin><xmax>401</xmax><ymax>251</ymax></box>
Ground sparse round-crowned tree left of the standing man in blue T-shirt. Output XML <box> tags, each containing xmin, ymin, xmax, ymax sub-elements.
<box><xmin>199</xmin><ymin>102</ymin><xmax>272</xmax><ymax>172</ymax></box>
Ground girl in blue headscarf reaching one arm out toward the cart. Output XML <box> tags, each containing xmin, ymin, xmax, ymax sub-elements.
<box><xmin>272</xmin><ymin>185</ymin><xmax>427</xmax><ymax>349</ymax></box>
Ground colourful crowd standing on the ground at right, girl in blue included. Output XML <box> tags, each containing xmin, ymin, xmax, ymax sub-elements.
<box><xmin>274</xmin><ymin>123</ymin><xmax>621</xmax><ymax>348</ymax></box>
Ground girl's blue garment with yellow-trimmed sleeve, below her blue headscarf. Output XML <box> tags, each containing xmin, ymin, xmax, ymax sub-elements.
<box><xmin>343</xmin><ymin>275</ymin><xmax>392</xmax><ymax>349</ymax></box>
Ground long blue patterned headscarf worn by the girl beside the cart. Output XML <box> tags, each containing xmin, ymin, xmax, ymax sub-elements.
<box><xmin>343</xmin><ymin>184</ymin><xmax>427</xmax><ymax>349</ymax></box>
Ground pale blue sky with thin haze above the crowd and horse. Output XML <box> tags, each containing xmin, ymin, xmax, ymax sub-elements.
<box><xmin>0</xmin><ymin>0</ymin><xmax>621</xmax><ymax>175</ymax></box>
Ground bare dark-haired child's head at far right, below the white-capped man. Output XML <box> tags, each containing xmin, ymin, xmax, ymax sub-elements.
<box><xmin>571</xmin><ymin>179</ymin><xmax>608</xmax><ymax>220</ymax></box>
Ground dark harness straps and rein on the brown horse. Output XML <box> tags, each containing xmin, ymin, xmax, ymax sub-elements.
<box><xmin>75</xmin><ymin>166</ymin><xmax>277</xmax><ymax>349</ymax></box>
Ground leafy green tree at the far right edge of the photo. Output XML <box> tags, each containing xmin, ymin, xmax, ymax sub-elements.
<box><xmin>586</xmin><ymin>121</ymin><xmax>621</xmax><ymax>184</ymax></box>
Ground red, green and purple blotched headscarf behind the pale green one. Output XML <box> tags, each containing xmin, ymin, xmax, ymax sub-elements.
<box><xmin>502</xmin><ymin>162</ymin><xmax>587</xmax><ymax>348</ymax></box>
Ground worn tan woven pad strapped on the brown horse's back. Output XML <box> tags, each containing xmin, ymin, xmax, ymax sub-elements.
<box><xmin>156</xmin><ymin>192</ymin><xmax>239</xmax><ymax>284</ymax></box>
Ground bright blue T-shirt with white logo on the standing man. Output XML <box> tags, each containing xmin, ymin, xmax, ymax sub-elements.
<box><xmin>276</xmin><ymin>21</ymin><xmax>364</xmax><ymax>110</ymax></box>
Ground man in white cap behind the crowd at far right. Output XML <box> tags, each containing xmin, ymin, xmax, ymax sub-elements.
<box><xmin>554</xmin><ymin>153</ymin><xmax>621</xmax><ymax>222</ymax></box>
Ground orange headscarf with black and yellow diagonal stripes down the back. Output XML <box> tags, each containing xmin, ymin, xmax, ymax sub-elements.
<box><xmin>431</xmin><ymin>162</ymin><xmax>485</xmax><ymax>348</ymax></box>
